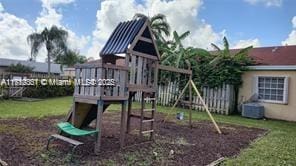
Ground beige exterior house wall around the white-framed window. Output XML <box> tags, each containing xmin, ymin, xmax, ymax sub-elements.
<box><xmin>238</xmin><ymin>71</ymin><xmax>296</xmax><ymax>121</ymax></box>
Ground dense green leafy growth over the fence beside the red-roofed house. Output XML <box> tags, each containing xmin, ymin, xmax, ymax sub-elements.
<box><xmin>200</xmin><ymin>37</ymin><xmax>253</xmax><ymax>87</ymax></box>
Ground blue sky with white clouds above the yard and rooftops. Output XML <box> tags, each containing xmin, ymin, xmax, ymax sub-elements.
<box><xmin>0</xmin><ymin>0</ymin><xmax>296</xmax><ymax>61</ymax></box>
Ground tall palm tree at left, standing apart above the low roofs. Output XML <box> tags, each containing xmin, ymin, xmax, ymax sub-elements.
<box><xmin>27</xmin><ymin>26</ymin><xmax>68</xmax><ymax>75</ymax></box>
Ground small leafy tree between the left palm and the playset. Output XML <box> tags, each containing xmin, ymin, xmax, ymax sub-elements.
<box><xmin>54</xmin><ymin>50</ymin><xmax>87</xmax><ymax>66</ymax></box>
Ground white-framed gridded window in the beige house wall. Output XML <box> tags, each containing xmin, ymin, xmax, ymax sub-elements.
<box><xmin>257</xmin><ymin>76</ymin><xmax>288</xmax><ymax>104</ymax></box>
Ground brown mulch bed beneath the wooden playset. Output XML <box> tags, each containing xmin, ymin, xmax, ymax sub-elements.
<box><xmin>0</xmin><ymin>112</ymin><xmax>266</xmax><ymax>165</ymax></box>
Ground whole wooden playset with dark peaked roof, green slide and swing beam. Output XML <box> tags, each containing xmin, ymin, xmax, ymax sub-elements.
<box><xmin>50</xmin><ymin>19</ymin><xmax>221</xmax><ymax>153</ymax></box>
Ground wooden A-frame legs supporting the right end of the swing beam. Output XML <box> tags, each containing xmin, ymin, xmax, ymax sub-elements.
<box><xmin>164</xmin><ymin>79</ymin><xmax>222</xmax><ymax>134</ymax></box>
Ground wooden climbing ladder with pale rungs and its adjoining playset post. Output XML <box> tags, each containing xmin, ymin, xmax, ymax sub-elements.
<box><xmin>127</xmin><ymin>91</ymin><xmax>156</xmax><ymax>140</ymax></box>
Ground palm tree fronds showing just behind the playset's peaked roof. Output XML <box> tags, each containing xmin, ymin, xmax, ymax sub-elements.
<box><xmin>134</xmin><ymin>13</ymin><xmax>171</xmax><ymax>42</ymax></box>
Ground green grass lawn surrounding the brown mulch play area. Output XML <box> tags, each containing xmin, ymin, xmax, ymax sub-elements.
<box><xmin>0</xmin><ymin>97</ymin><xmax>296</xmax><ymax>165</ymax></box>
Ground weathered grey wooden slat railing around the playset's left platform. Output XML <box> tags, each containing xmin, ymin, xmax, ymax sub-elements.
<box><xmin>74</xmin><ymin>64</ymin><xmax>128</xmax><ymax>100</ymax></box>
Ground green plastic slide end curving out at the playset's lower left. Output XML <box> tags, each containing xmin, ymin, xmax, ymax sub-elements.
<box><xmin>58</xmin><ymin>122</ymin><xmax>99</xmax><ymax>136</ymax></box>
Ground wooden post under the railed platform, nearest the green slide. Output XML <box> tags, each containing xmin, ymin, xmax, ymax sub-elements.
<box><xmin>95</xmin><ymin>100</ymin><xmax>104</xmax><ymax>154</ymax></box>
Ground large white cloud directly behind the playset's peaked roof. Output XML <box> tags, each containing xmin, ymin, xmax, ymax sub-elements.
<box><xmin>88</xmin><ymin>0</ymin><xmax>225</xmax><ymax>58</ymax></box>
